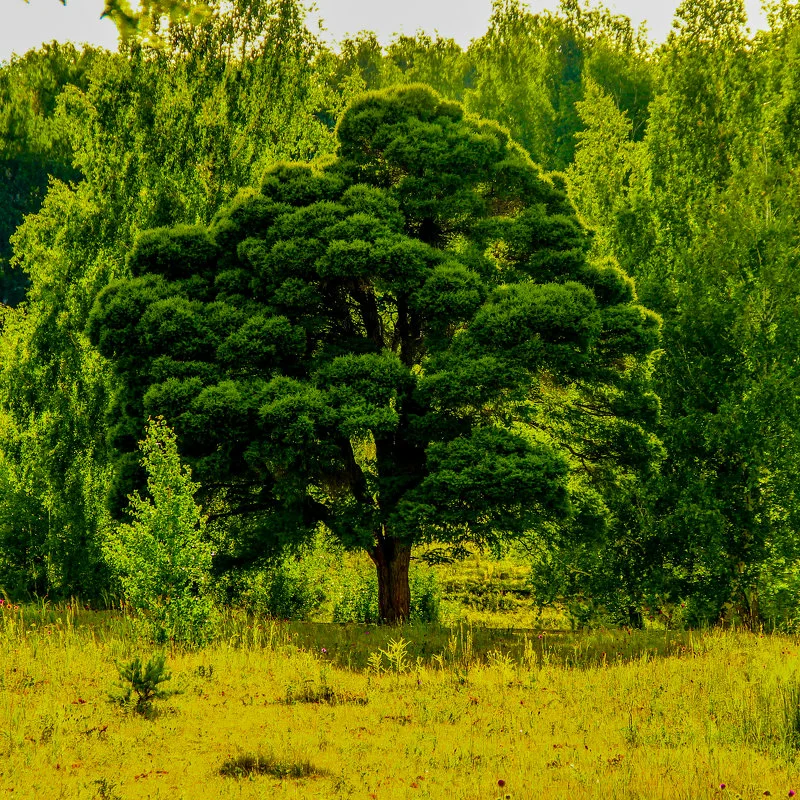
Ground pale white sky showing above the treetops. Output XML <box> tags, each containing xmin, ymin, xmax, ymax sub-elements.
<box><xmin>0</xmin><ymin>0</ymin><xmax>764</xmax><ymax>61</ymax></box>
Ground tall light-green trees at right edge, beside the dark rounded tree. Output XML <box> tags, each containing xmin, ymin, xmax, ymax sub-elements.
<box><xmin>568</xmin><ymin>0</ymin><xmax>800</xmax><ymax>625</ymax></box>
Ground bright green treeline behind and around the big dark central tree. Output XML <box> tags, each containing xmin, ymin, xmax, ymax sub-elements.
<box><xmin>0</xmin><ymin>0</ymin><xmax>800</xmax><ymax>627</ymax></box>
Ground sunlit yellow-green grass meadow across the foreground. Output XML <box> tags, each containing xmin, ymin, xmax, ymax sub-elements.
<box><xmin>0</xmin><ymin>607</ymin><xmax>800</xmax><ymax>800</ymax></box>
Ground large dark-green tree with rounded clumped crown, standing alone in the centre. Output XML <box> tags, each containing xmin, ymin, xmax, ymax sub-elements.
<box><xmin>89</xmin><ymin>86</ymin><xmax>659</xmax><ymax>621</ymax></box>
